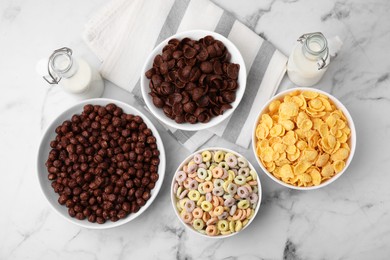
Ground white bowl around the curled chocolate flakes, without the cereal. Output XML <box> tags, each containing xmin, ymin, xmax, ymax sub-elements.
<box><xmin>141</xmin><ymin>30</ymin><xmax>246</xmax><ymax>131</ymax></box>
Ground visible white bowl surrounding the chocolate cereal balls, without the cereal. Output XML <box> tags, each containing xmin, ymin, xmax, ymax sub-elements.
<box><xmin>37</xmin><ymin>98</ymin><xmax>165</xmax><ymax>229</ymax></box>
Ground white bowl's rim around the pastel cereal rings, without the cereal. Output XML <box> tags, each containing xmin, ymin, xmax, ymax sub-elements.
<box><xmin>171</xmin><ymin>147</ymin><xmax>262</xmax><ymax>239</ymax></box>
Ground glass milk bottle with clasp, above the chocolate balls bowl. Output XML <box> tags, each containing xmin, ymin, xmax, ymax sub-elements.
<box><xmin>43</xmin><ymin>47</ymin><xmax>104</xmax><ymax>99</ymax></box>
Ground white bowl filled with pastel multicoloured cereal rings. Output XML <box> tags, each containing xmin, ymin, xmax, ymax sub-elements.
<box><xmin>171</xmin><ymin>147</ymin><xmax>261</xmax><ymax>238</ymax></box>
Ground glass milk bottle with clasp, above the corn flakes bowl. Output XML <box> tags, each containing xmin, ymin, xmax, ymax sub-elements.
<box><xmin>287</xmin><ymin>32</ymin><xmax>330</xmax><ymax>87</ymax></box>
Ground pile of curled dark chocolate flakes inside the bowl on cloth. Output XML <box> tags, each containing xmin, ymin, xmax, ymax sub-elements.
<box><xmin>145</xmin><ymin>35</ymin><xmax>240</xmax><ymax>124</ymax></box>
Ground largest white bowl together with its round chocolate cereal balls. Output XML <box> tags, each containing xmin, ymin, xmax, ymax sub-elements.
<box><xmin>37</xmin><ymin>98</ymin><xmax>165</xmax><ymax>229</ymax></box>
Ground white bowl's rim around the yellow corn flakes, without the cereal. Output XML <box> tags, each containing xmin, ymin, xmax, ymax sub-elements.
<box><xmin>252</xmin><ymin>88</ymin><xmax>356</xmax><ymax>190</ymax></box>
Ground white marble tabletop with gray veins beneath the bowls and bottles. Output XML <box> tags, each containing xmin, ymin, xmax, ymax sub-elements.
<box><xmin>0</xmin><ymin>0</ymin><xmax>390</xmax><ymax>260</ymax></box>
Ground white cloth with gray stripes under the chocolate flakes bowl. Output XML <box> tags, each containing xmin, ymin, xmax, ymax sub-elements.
<box><xmin>84</xmin><ymin>0</ymin><xmax>287</xmax><ymax>151</ymax></box>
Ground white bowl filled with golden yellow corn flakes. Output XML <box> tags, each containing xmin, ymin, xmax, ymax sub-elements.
<box><xmin>252</xmin><ymin>88</ymin><xmax>356</xmax><ymax>190</ymax></box>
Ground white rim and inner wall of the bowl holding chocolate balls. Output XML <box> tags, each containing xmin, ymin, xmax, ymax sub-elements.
<box><xmin>36</xmin><ymin>98</ymin><xmax>166</xmax><ymax>230</ymax></box>
